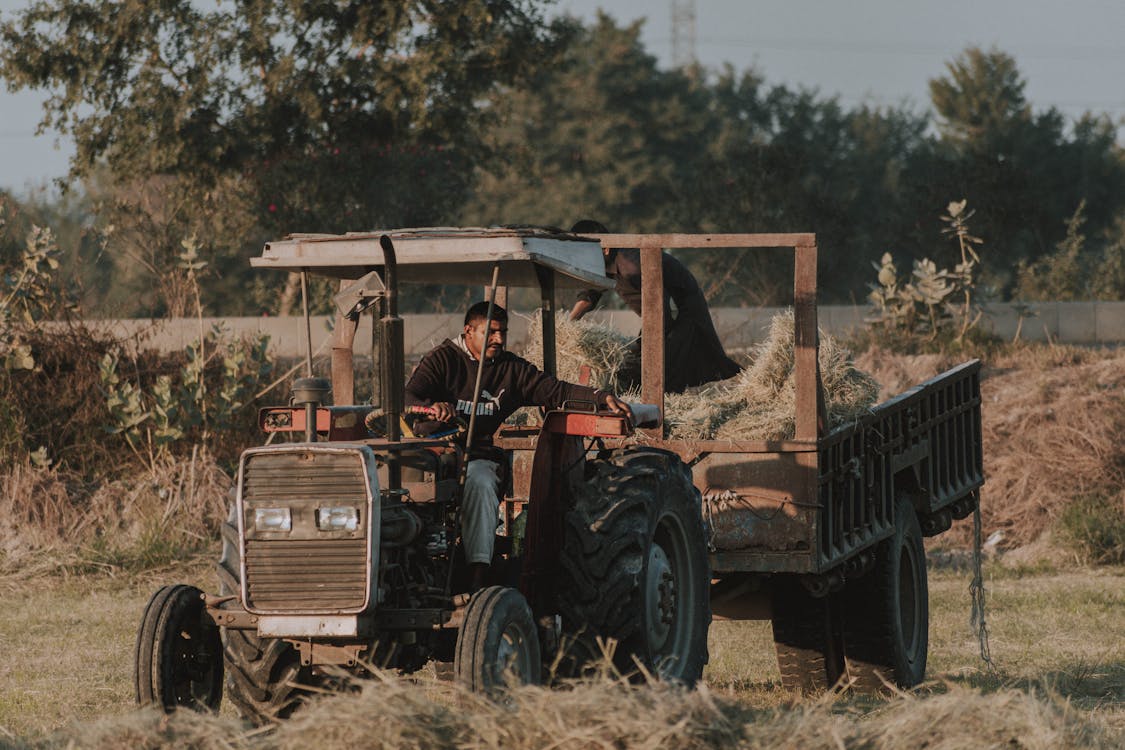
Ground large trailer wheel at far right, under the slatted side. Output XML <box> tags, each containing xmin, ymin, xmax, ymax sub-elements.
<box><xmin>844</xmin><ymin>498</ymin><xmax>929</xmax><ymax>693</ymax></box>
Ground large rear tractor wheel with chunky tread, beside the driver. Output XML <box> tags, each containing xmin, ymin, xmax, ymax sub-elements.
<box><xmin>559</xmin><ymin>449</ymin><xmax>711</xmax><ymax>685</ymax></box>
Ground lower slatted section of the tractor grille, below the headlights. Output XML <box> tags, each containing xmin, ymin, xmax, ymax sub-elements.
<box><xmin>246</xmin><ymin>539</ymin><xmax>367</xmax><ymax>613</ymax></box>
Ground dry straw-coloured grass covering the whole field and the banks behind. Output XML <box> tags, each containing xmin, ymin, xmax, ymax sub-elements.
<box><xmin>0</xmin><ymin>346</ymin><xmax>1125</xmax><ymax>750</ymax></box>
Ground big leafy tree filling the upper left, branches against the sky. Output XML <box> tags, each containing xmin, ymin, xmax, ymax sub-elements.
<box><xmin>0</xmin><ymin>0</ymin><xmax>552</xmax><ymax>314</ymax></box>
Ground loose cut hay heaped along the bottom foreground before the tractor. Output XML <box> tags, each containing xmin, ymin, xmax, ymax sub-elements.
<box><xmin>30</xmin><ymin>678</ymin><xmax>1123</xmax><ymax>750</ymax></box>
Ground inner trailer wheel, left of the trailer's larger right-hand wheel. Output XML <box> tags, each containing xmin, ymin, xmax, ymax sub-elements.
<box><xmin>771</xmin><ymin>577</ymin><xmax>844</xmax><ymax>694</ymax></box>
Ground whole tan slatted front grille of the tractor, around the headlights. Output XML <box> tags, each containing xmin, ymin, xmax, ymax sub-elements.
<box><xmin>242</xmin><ymin>449</ymin><xmax>371</xmax><ymax>614</ymax></box>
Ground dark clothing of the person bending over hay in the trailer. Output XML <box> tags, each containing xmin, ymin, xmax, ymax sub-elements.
<box><xmin>578</xmin><ymin>249</ymin><xmax>741</xmax><ymax>394</ymax></box>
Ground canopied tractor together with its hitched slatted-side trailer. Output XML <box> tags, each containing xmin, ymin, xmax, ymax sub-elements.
<box><xmin>135</xmin><ymin>227</ymin><xmax>983</xmax><ymax>722</ymax></box>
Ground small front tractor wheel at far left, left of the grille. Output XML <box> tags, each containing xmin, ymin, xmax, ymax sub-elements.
<box><xmin>133</xmin><ymin>585</ymin><xmax>223</xmax><ymax>713</ymax></box>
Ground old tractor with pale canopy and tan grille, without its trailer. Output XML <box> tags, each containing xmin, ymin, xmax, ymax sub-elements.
<box><xmin>135</xmin><ymin>228</ymin><xmax>711</xmax><ymax>723</ymax></box>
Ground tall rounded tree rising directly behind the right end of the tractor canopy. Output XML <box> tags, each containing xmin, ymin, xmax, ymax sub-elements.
<box><xmin>462</xmin><ymin>13</ymin><xmax>714</xmax><ymax>232</ymax></box>
